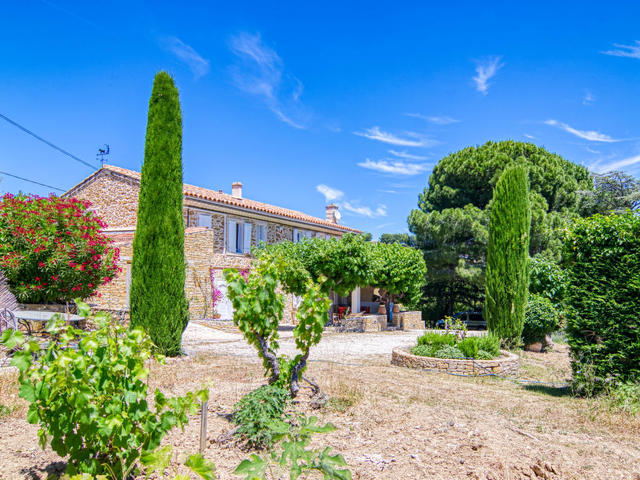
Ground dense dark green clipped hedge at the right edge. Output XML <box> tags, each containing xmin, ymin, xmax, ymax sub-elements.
<box><xmin>564</xmin><ymin>212</ymin><xmax>640</xmax><ymax>390</ymax></box>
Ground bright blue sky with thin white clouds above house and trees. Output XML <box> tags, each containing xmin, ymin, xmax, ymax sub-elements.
<box><xmin>0</xmin><ymin>0</ymin><xmax>640</xmax><ymax>237</ymax></box>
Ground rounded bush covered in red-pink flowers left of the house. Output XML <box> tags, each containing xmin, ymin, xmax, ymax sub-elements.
<box><xmin>0</xmin><ymin>194</ymin><xmax>119</xmax><ymax>303</ymax></box>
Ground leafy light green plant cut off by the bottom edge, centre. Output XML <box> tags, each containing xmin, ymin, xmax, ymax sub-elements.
<box><xmin>234</xmin><ymin>416</ymin><xmax>351</xmax><ymax>480</ymax></box>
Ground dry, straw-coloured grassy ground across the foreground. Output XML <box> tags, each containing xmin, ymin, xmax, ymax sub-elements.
<box><xmin>0</xmin><ymin>346</ymin><xmax>640</xmax><ymax>480</ymax></box>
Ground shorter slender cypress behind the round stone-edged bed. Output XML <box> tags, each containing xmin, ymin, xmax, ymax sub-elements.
<box><xmin>484</xmin><ymin>164</ymin><xmax>531</xmax><ymax>346</ymax></box>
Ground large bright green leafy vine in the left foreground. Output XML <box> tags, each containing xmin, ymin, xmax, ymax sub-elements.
<box><xmin>2</xmin><ymin>301</ymin><xmax>207</xmax><ymax>478</ymax></box>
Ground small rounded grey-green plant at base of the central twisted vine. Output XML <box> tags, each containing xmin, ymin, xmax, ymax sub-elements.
<box><xmin>233</xmin><ymin>385</ymin><xmax>291</xmax><ymax>448</ymax></box>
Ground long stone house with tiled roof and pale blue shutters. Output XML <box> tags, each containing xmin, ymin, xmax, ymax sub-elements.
<box><xmin>64</xmin><ymin>165</ymin><xmax>360</xmax><ymax>323</ymax></box>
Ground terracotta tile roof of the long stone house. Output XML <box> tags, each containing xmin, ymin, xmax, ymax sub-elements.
<box><xmin>102</xmin><ymin>165</ymin><xmax>360</xmax><ymax>233</ymax></box>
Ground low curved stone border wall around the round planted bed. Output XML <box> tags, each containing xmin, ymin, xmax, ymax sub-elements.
<box><xmin>391</xmin><ymin>347</ymin><xmax>520</xmax><ymax>376</ymax></box>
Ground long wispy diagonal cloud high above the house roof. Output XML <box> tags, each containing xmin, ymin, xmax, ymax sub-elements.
<box><xmin>230</xmin><ymin>32</ymin><xmax>308</xmax><ymax>129</ymax></box>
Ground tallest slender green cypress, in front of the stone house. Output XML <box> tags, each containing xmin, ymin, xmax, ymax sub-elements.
<box><xmin>130</xmin><ymin>72</ymin><xmax>189</xmax><ymax>356</ymax></box>
